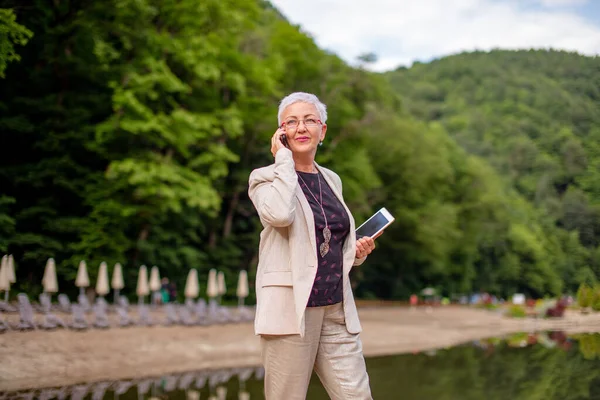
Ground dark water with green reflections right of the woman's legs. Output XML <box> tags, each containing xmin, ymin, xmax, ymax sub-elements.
<box><xmin>356</xmin><ymin>332</ymin><xmax>600</xmax><ymax>400</ymax></box>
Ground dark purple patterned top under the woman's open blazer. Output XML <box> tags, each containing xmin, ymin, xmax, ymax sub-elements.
<box><xmin>297</xmin><ymin>171</ymin><xmax>350</xmax><ymax>307</ymax></box>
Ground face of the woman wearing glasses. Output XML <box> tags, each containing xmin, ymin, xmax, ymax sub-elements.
<box><xmin>281</xmin><ymin>102</ymin><xmax>327</xmax><ymax>154</ymax></box>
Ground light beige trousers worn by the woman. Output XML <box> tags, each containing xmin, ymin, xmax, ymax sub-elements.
<box><xmin>261</xmin><ymin>303</ymin><xmax>372</xmax><ymax>400</ymax></box>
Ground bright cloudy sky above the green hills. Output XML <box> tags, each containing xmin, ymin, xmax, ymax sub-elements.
<box><xmin>271</xmin><ymin>0</ymin><xmax>600</xmax><ymax>71</ymax></box>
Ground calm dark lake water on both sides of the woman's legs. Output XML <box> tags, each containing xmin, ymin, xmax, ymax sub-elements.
<box><xmin>8</xmin><ymin>332</ymin><xmax>600</xmax><ymax>400</ymax></box>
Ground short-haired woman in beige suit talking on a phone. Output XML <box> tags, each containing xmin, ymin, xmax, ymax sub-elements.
<box><xmin>248</xmin><ymin>92</ymin><xmax>375</xmax><ymax>400</ymax></box>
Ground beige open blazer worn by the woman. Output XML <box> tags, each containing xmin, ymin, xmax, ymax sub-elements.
<box><xmin>248</xmin><ymin>148</ymin><xmax>365</xmax><ymax>336</ymax></box>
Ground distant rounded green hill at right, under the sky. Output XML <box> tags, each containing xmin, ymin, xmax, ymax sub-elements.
<box><xmin>372</xmin><ymin>50</ymin><xmax>600</xmax><ymax>296</ymax></box>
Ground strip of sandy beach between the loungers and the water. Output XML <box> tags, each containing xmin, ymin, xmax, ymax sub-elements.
<box><xmin>0</xmin><ymin>306</ymin><xmax>600</xmax><ymax>391</ymax></box>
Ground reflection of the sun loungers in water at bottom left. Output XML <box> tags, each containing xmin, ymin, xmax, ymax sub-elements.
<box><xmin>0</xmin><ymin>367</ymin><xmax>264</xmax><ymax>400</ymax></box>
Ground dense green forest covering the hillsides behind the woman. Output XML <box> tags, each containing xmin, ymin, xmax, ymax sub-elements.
<box><xmin>0</xmin><ymin>0</ymin><xmax>600</xmax><ymax>300</ymax></box>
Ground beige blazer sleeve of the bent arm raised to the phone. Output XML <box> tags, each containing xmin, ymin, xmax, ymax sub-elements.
<box><xmin>248</xmin><ymin>148</ymin><xmax>298</xmax><ymax>227</ymax></box>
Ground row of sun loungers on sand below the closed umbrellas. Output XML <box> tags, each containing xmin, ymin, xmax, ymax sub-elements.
<box><xmin>0</xmin><ymin>293</ymin><xmax>254</xmax><ymax>333</ymax></box>
